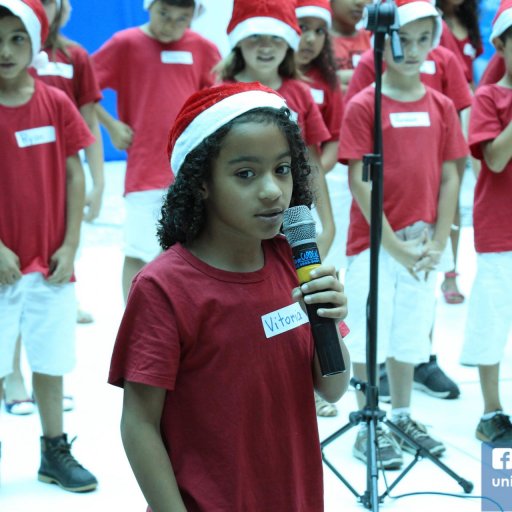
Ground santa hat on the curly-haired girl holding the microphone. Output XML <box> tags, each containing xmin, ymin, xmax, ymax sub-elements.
<box><xmin>167</xmin><ymin>82</ymin><xmax>286</xmax><ymax>175</ymax></box>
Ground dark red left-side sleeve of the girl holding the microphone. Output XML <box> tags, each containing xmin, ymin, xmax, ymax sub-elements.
<box><xmin>108</xmin><ymin>275</ymin><xmax>181</xmax><ymax>390</ymax></box>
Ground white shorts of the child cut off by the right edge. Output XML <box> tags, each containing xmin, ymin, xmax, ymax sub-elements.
<box><xmin>460</xmin><ymin>252</ymin><xmax>512</xmax><ymax>365</ymax></box>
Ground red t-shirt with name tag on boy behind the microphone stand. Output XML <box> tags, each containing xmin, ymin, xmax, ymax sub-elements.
<box><xmin>339</xmin><ymin>86</ymin><xmax>468</xmax><ymax>256</ymax></box>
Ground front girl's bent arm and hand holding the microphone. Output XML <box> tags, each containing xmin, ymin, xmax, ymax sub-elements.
<box><xmin>293</xmin><ymin>265</ymin><xmax>350</xmax><ymax>402</ymax></box>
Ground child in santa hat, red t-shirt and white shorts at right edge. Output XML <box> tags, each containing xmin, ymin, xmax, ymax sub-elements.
<box><xmin>461</xmin><ymin>0</ymin><xmax>512</xmax><ymax>443</ymax></box>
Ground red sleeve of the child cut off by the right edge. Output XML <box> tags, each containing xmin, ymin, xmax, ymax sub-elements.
<box><xmin>469</xmin><ymin>87</ymin><xmax>503</xmax><ymax>160</ymax></box>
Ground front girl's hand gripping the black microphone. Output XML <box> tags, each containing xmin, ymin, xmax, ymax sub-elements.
<box><xmin>292</xmin><ymin>265</ymin><xmax>348</xmax><ymax>320</ymax></box>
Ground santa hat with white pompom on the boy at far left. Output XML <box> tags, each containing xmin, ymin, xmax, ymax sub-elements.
<box><xmin>0</xmin><ymin>0</ymin><xmax>50</xmax><ymax>69</ymax></box>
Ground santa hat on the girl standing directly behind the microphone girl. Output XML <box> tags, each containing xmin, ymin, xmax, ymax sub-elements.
<box><xmin>227</xmin><ymin>0</ymin><xmax>300</xmax><ymax>50</ymax></box>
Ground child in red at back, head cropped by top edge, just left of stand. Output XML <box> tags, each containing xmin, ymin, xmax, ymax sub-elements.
<box><xmin>331</xmin><ymin>0</ymin><xmax>371</xmax><ymax>92</ymax></box>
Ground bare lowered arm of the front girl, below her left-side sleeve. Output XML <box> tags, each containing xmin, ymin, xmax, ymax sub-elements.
<box><xmin>121</xmin><ymin>382</ymin><xmax>186</xmax><ymax>512</ymax></box>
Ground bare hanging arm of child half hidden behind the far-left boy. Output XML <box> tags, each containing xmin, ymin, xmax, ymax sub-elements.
<box><xmin>80</xmin><ymin>103</ymin><xmax>105</xmax><ymax>222</ymax></box>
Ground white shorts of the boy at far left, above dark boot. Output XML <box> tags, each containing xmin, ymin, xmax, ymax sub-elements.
<box><xmin>0</xmin><ymin>272</ymin><xmax>76</xmax><ymax>378</ymax></box>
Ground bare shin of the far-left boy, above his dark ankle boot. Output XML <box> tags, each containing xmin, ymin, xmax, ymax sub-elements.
<box><xmin>32</xmin><ymin>373</ymin><xmax>63</xmax><ymax>438</ymax></box>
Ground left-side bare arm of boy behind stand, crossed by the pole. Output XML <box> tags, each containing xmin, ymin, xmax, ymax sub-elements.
<box><xmin>349</xmin><ymin>160</ymin><xmax>426</xmax><ymax>278</ymax></box>
